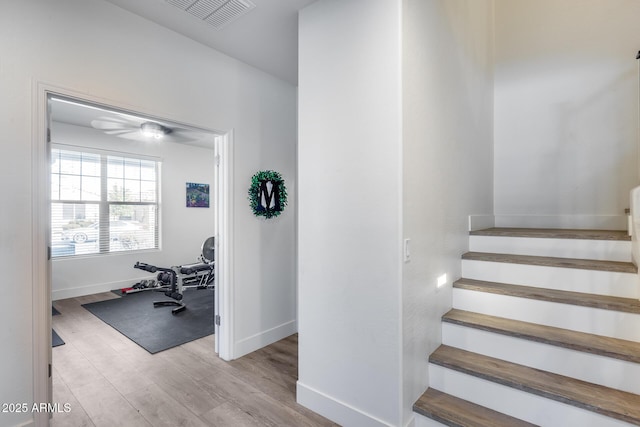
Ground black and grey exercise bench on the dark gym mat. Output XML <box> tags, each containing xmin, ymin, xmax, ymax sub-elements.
<box><xmin>133</xmin><ymin>237</ymin><xmax>215</xmax><ymax>314</ymax></box>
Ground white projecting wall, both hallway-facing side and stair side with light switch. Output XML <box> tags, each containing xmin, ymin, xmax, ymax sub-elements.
<box><xmin>298</xmin><ymin>0</ymin><xmax>493</xmax><ymax>425</ymax></box>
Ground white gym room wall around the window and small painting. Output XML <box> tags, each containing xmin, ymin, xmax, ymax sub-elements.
<box><xmin>51</xmin><ymin>121</ymin><xmax>215</xmax><ymax>300</ymax></box>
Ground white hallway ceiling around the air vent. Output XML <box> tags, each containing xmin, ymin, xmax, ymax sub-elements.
<box><xmin>106</xmin><ymin>0</ymin><xmax>316</xmax><ymax>86</ymax></box>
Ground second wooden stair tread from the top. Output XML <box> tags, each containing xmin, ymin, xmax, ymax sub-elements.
<box><xmin>462</xmin><ymin>252</ymin><xmax>638</xmax><ymax>274</ymax></box>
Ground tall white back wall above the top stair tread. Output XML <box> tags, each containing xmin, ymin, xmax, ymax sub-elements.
<box><xmin>495</xmin><ymin>0</ymin><xmax>640</xmax><ymax>228</ymax></box>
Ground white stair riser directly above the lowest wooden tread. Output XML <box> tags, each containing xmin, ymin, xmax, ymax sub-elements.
<box><xmin>429</xmin><ymin>363</ymin><xmax>631</xmax><ymax>427</ymax></box>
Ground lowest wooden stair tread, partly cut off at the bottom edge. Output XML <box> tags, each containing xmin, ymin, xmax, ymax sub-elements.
<box><xmin>413</xmin><ymin>388</ymin><xmax>535</xmax><ymax>427</ymax></box>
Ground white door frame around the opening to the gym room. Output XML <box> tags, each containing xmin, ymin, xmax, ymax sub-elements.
<box><xmin>31</xmin><ymin>80</ymin><xmax>234</xmax><ymax>426</ymax></box>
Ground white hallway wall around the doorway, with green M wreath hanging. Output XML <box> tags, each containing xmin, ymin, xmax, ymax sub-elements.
<box><xmin>0</xmin><ymin>0</ymin><xmax>296</xmax><ymax>426</ymax></box>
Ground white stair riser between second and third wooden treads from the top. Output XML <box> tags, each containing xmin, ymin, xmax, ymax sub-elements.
<box><xmin>462</xmin><ymin>260</ymin><xmax>640</xmax><ymax>299</ymax></box>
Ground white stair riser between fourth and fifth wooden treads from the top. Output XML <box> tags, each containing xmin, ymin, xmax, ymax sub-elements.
<box><xmin>442</xmin><ymin>322</ymin><xmax>640</xmax><ymax>394</ymax></box>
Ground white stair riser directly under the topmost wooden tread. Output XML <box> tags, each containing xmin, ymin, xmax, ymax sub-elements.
<box><xmin>469</xmin><ymin>236</ymin><xmax>631</xmax><ymax>262</ymax></box>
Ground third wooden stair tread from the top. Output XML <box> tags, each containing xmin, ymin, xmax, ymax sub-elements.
<box><xmin>453</xmin><ymin>278</ymin><xmax>640</xmax><ymax>314</ymax></box>
